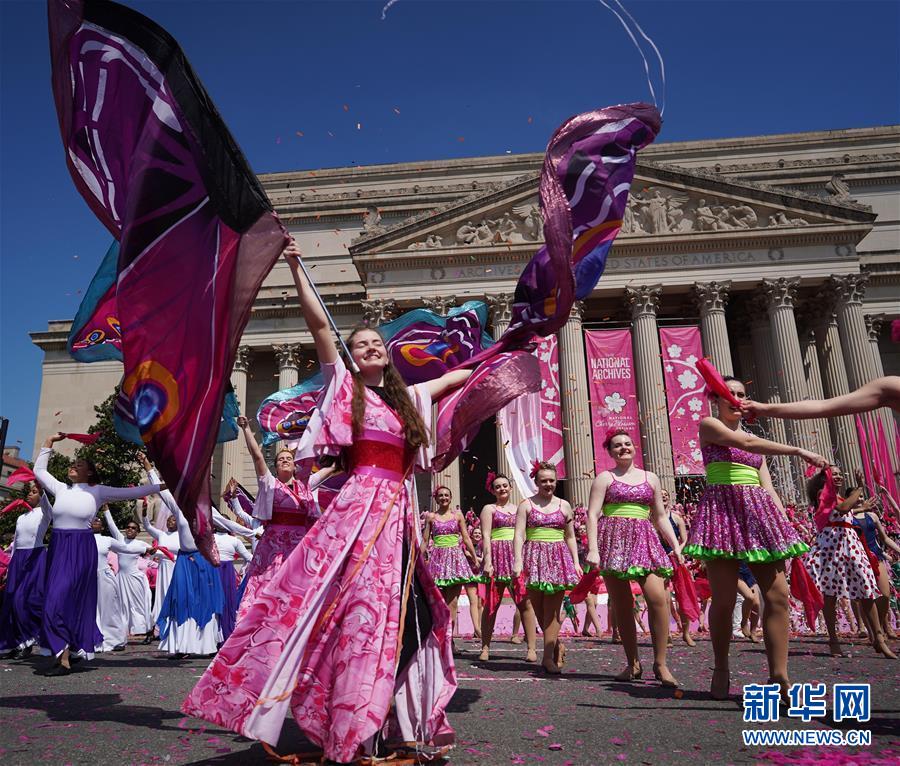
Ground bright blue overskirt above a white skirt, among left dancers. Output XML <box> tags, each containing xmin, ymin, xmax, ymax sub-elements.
<box><xmin>156</xmin><ymin>551</ymin><xmax>224</xmax><ymax>641</ymax></box>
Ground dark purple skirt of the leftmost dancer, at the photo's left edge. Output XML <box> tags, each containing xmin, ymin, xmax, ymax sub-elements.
<box><xmin>0</xmin><ymin>545</ymin><xmax>47</xmax><ymax>652</ymax></box>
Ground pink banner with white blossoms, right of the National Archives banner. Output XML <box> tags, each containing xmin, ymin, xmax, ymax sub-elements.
<box><xmin>659</xmin><ymin>327</ymin><xmax>709</xmax><ymax>476</ymax></box>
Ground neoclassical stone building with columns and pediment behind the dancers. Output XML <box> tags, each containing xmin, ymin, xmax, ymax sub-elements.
<box><xmin>32</xmin><ymin>126</ymin><xmax>900</xmax><ymax>507</ymax></box>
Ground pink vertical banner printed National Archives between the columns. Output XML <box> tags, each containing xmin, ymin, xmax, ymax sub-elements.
<box><xmin>584</xmin><ymin>330</ymin><xmax>644</xmax><ymax>473</ymax></box>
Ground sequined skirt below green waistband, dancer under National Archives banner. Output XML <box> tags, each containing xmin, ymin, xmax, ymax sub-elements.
<box><xmin>597</xmin><ymin>516</ymin><xmax>672</xmax><ymax>580</ymax></box>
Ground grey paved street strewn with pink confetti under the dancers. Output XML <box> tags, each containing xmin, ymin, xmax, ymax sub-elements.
<box><xmin>0</xmin><ymin>639</ymin><xmax>900</xmax><ymax>766</ymax></box>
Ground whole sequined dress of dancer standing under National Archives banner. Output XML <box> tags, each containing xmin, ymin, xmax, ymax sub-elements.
<box><xmin>597</xmin><ymin>476</ymin><xmax>672</xmax><ymax>580</ymax></box>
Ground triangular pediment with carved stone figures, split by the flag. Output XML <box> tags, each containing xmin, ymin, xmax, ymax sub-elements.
<box><xmin>350</xmin><ymin>161</ymin><xmax>875</xmax><ymax>256</ymax></box>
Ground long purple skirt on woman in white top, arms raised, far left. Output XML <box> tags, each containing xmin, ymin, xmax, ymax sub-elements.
<box><xmin>41</xmin><ymin>529</ymin><xmax>103</xmax><ymax>657</ymax></box>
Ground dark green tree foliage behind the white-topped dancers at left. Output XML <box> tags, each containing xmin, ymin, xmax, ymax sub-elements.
<box><xmin>0</xmin><ymin>387</ymin><xmax>146</xmax><ymax>539</ymax></box>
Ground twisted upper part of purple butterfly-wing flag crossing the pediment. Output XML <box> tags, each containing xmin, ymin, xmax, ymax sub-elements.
<box><xmin>469</xmin><ymin>103</ymin><xmax>661</xmax><ymax>364</ymax></box>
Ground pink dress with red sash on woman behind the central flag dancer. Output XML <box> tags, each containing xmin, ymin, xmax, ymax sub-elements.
<box><xmin>236</xmin><ymin>473</ymin><xmax>316</xmax><ymax>622</ymax></box>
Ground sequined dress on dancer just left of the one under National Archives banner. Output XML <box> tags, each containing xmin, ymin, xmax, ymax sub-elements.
<box><xmin>522</xmin><ymin>504</ymin><xmax>579</xmax><ymax>593</ymax></box>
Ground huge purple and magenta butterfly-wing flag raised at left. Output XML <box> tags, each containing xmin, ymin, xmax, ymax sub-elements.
<box><xmin>48</xmin><ymin>0</ymin><xmax>287</xmax><ymax>561</ymax></box>
